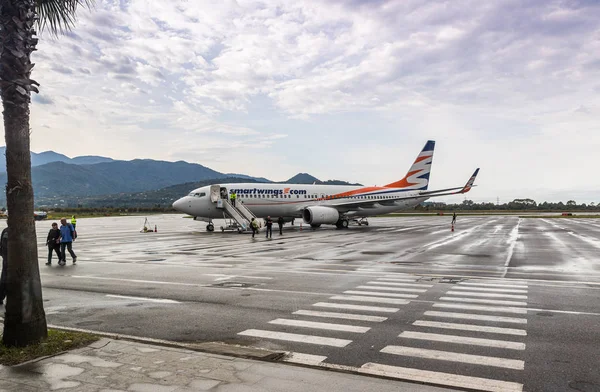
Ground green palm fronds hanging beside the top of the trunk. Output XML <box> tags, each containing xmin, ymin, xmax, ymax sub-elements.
<box><xmin>35</xmin><ymin>0</ymin><xmax>94</xmax><ymax>35</ymax></box>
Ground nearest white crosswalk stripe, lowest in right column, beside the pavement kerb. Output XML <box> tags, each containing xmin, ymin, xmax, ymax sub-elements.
<box><xmin>359</xmin><ymin>362</ymin><xmax>523</xmax><ymax>392</ymax></box>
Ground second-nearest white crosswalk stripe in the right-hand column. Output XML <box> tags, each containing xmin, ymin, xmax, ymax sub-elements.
<box><xmin>381</xmin><ymin>346</ymin><xmax>525</xmax><ymax>370</ymax></box>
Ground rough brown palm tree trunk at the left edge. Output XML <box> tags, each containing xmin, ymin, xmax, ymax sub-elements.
<box><xmin>0</xmin><ymin>0</ymin><xmax>47</xmax><ymax>347</ymax></box>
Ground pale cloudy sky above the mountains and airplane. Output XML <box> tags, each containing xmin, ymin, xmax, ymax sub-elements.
<box><xmin>8</xmin><ymin>0</ymin><xmax>600</xmax><ymax>203</ymax></box>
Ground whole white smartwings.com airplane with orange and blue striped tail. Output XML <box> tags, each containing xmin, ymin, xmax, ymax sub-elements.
<box><xmin>173</xmin><ymin>140</ymin><xmax>479</xmax><ymax>231</ymax></box>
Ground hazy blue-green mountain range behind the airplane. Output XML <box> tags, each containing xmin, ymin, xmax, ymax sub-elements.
<box><xmin>0</xmin><ymin>147</ymin><xmax>359</xmax><ymax>206</ymax></box>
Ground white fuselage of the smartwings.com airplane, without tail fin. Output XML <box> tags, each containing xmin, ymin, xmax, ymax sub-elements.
<box><xmin>173</xmin><ymin>183</ymin><xmax>427</xmax><ymax>219</ymax></box>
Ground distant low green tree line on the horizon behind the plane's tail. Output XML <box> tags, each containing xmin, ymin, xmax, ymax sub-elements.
<box><xmin>417</xmin><ymin>199</ymin><xmax>600</xmax><ymax>212</ymax></box>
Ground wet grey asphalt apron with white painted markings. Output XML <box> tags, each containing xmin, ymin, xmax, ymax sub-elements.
<box><xmin>11</xmin><ymin>215</ymin><xmax>600</xmax><ymax>392</ymax></box>
